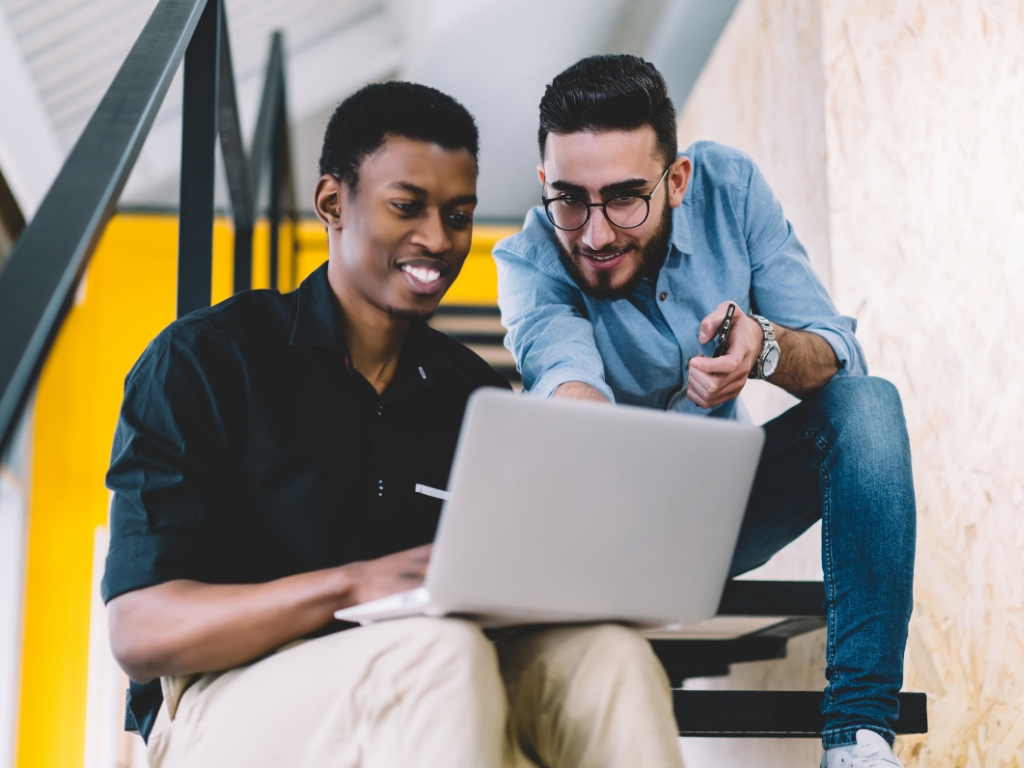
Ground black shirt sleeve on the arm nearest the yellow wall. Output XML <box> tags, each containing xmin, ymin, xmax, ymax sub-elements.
<box><xmin>101</xmin><ymin>332</ymin><xmax>239</xmax><ymax>601</ymax></box>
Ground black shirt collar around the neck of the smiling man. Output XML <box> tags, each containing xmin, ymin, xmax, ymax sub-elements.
<box><xmin>290</xmin><ymin>262</ymin><xmax>465</xmax><ymax>384</ymax></box>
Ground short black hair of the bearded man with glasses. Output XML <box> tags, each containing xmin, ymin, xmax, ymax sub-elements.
<box><xmin>537</xmin><ymin>53</ymin><xmax>678</xmax><ymax>166</ymax></box>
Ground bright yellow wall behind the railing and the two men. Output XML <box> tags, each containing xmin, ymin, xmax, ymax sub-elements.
<box><xmin>16</xmin><ymin>215</ymin><xmax>512</xmax><ymax>768</ymax></box>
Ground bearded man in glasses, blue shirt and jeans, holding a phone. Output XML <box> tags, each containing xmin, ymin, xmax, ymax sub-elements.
<box><xmin>495</xmin><ymin>55</ymin><xmax>915</xmax><ymax>768</ymax></box>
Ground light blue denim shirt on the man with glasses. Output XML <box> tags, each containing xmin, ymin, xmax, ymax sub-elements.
<box><xmin>494</xmin><ymin>141</ymin><xmax>867</xmax><ymax>418</ymax></box>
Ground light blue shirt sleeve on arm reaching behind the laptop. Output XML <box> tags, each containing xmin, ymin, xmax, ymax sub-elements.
<box><xmin>494</xmin><ymin>244</ymin><xmax>614</xmax><ymax>401</ymax></box>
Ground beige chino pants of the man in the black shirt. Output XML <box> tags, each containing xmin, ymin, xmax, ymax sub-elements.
<box><xmin>148</xmin><ymin>617</ymin><xmax>682</xmax><ymax>768</ymax></box>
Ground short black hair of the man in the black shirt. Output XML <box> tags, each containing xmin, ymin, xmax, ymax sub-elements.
<box><xmin>319</xmin><ymin>81</ymin><xmax>480</xmax><ymax>191</ymax></box>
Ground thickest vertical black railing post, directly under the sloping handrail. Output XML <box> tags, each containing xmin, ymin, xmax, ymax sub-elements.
<box><xmin>177</xmin><ymin>0</ymin><xmax>221</xmax><ymax>317</ymax></box>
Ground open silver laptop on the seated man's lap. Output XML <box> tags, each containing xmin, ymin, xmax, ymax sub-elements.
<box><xmin>335</xmin><ymin>389</ymin><xmax>764</xmax><ymax>627</ymax></box>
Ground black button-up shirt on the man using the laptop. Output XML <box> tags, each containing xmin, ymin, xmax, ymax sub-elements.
<box><xmin>102</xmin><ymin>265</ymin><xmax>509</xmax><ymax>735</ymax></box>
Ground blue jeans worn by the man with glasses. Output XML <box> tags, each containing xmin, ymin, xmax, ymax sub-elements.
<box><xmin>730</xmin><ymin>376</ymin><xmax>916</xmax><ymax>749</ymax></box>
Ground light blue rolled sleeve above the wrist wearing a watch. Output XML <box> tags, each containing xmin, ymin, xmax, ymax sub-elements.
<box><xmin>744</xmin><ymin>163</ymin><xmax>867</xmax><ymax>376</ymax></box>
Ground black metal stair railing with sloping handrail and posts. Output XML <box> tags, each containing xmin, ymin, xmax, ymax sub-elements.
<box><xmin>0</xmin><ymin>0</ymin><xmax>291</xmax><ymax>452</ymax></box>
